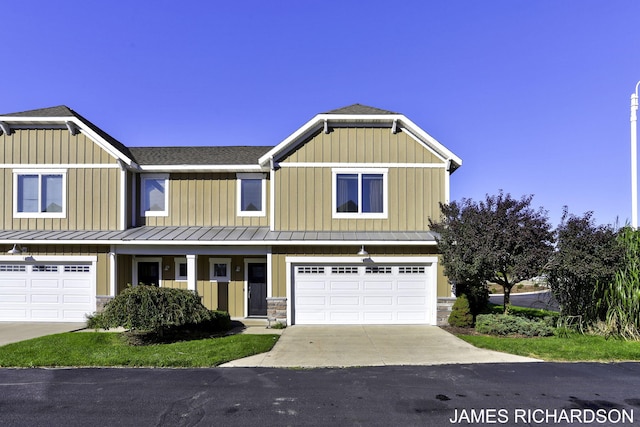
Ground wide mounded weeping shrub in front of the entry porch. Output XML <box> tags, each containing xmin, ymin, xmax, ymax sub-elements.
<box><xmin>87</xmin><ymin>285</ymin><xmax>219</xmax><ymax>335</ymax></box>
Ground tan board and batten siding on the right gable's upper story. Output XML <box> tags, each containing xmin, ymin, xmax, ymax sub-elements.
<box><xmin>275</xmin><ymin>128</ymin><xmax>448</xmax><ymax>231</ymax></box>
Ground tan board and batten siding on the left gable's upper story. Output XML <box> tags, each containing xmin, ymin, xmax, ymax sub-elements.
<box><xmin>0</xmin><ymin>129</ymin><xmax>120</xmax><ymax>230</ymax></box>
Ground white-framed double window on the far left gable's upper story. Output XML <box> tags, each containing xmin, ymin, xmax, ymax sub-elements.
<box><xmin>13</xmin><ymin>169</ymin><xmax>67</xmax><ymax>218</ymax></box>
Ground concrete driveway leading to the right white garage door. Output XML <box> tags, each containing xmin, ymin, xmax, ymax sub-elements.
<box><xmin>221</xmin><ymin>325</ymin><xmax>539</xmax><ymax>368</ymax></box>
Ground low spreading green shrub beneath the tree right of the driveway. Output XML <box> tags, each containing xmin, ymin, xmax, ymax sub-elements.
<box><xmin>476</xmin><ymin>314</ymin><xmax>554</xmax><ymax>337</ymax></box>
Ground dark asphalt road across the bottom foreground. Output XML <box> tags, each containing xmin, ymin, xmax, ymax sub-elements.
<box><xmin>0</xmin><ymin>363</ymin><xmax>640</xmax><ymax>426</ymax></box>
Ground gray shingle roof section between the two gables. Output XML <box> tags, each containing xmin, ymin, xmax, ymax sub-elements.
<box><xmin>130</xmin><ymin>146</ymin><xmax>272</xmax><ymax>165</ymax></box>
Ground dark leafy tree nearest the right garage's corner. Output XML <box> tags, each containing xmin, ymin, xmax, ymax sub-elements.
<box><xmin>429</xmin><ymin>191</ymin><xmax>553</xmax><ymax>312</ymax></box>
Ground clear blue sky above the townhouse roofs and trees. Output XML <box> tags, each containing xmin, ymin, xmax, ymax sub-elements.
<box><xmin>0</xmin><ymin>0</ymin><xmax>640</xmax><ymax>224</ymax></box>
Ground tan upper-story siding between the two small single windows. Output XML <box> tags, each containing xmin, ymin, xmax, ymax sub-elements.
<box><xmin>138</xmin><ymin>173</ymin><xmax>269</xmax><ymax>227</ymax></box>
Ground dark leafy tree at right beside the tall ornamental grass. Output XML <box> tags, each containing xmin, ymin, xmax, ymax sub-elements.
<box><xmin>546</xmin><ymin>207</ymin><xmax>624</xmax><ymax>323</ymax></box>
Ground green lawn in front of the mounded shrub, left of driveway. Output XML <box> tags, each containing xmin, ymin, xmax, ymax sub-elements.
<box><xmin>0</xmin><ymin>332</ymin><xmax>278</xmax><ymax>368</ymax></box>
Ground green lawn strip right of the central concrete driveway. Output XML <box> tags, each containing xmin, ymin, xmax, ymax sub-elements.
<box><xmin>458</xmin><ymin>334</ymin><xmax>640</xmax><ymax>362</ymax></box>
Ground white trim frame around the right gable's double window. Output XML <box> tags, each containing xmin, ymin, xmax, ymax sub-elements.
<box><xmin>331</xmin><ymin>168</ymin><xmax>389</xmax><ymax>219</ymax></box>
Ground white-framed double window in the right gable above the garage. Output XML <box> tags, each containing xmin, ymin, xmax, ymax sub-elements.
<box><xmin>332</xmin><ymin>169</ymin><xmax>388</xmax><ymax>218</ymax></box>
